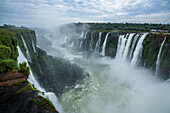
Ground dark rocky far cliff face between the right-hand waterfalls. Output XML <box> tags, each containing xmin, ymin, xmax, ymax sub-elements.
<box><xmin>67</xmin><ymin>31</ymin><xmax>170</xmax><ymax>79</ymax></box>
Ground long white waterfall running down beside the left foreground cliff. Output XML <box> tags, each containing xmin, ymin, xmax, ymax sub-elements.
<box><xmin>17</xmin><ymin>46</ymin><xmax>62</xmax><ymax>113</ymax></box>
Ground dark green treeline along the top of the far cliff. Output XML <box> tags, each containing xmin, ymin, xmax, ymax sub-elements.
<box><xmin>71</xmin><ymin>22</ymin><xmax>170</xmax><ymax>33</ymax></box>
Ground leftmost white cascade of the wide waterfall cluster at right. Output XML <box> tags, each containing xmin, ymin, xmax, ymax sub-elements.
<box><xmin>116</xmin><ymin>35</ymin><xmax>127</xmax><ymax>59</ymax></box>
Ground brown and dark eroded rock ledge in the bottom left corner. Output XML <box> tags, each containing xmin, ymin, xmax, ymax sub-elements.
<box><xmin>0</xmin><ymin>72</ymin><xmax>58</xmax><ymax>113</ymax></box>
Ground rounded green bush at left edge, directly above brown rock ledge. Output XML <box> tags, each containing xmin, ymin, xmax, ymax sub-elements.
<box><xmin>0</xmin><ymin>59</ymin><xmax>18</xmax><ymax>73</ymax></box>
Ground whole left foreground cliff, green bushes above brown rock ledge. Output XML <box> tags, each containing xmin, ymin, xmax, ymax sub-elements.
<box><xmin>0</xmin><ymin>29</ymin><xmax>58</xmax><ymax>113</ymax></box>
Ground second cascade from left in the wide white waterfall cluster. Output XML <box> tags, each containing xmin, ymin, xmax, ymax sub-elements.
<box><xmin>123</xmin><ymin>33</ymin><xmax>135</xmax><ymax>59</ymax></box>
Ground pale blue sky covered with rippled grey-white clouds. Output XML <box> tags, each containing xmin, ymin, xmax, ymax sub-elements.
<box><xmin>0</xmin><ymin>0</ymin><xmax>170</xmax><ymax>27</ymax></box>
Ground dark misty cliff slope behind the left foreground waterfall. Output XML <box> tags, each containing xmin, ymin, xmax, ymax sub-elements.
<box><xmin>16</xmin><ymin>30</ymin><xmax>88</xmax><ymax>95</ymax></box>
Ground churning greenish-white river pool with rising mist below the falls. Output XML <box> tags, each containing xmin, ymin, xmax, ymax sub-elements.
<box><xmin>60</xmin><ymin>55</ymin><xmax>170</xmax><ymax>113</ymax></box>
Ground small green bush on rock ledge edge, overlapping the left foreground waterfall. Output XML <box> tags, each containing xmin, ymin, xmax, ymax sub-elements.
<box><xmin>18</xmin><ymin>62</ymin><xmax>30</xmax><ymax>76</ymax></box>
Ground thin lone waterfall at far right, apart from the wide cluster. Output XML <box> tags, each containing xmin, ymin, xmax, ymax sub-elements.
<box><xmin>155</xmin><ymin>36</ymin><xmax>167</xmax><ymax>76</ymax></box>
